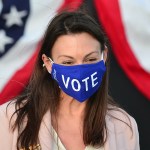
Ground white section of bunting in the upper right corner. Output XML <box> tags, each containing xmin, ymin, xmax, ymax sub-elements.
<box><xmin>119</xmin><ymin>0</ymin><xmax>150</xmax><ymax>73</ymax></box>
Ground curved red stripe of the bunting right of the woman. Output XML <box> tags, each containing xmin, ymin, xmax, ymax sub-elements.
<box><xmin>94</xmin><ymin>0</ymin><xmax>150</xmax><ymax>100</ymax></box>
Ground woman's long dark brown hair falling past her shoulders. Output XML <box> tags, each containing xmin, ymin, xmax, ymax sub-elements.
<box><xmin>10</xmin><ymin>11</ymin><xmax>122</xmax><ymax>149</ymax></box>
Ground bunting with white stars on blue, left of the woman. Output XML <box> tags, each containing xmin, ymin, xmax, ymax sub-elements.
<box><xmin>0</xmin><ymin>0</ymin><xmax>82</xmax><ymax>104</ymax></box>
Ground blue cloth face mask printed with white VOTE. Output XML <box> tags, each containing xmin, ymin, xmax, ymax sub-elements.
<box><xmin>51</xmin><ymin>53</ymin><xmax>106</xmax><ymax>102</ymax></box>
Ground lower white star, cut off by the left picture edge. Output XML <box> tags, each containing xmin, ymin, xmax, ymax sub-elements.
<box><xmin>0</xmin><ymin>30</ymin><xmax>14</xmax><ymax>53</ymax></box>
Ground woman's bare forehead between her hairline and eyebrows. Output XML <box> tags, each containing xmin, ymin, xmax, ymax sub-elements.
<box><xmin>52</xmin><ymin>32</ymin><xmax>100</xmax><ymax>57</ymax></box>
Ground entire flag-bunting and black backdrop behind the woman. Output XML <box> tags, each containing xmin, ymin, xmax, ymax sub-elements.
<box><xmin>0</xmin><ymin>0</ymin><xmax>150</xmax><ymax>150</ymax></box>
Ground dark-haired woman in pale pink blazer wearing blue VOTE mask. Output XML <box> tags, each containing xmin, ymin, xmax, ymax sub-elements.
<box><xmin>0</xmin><ymin>12</ymin><xmax>139</xmax><ymax>150</ymax></box>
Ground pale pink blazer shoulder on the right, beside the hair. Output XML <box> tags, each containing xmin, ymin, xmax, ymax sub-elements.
<box><xmin>106</xmin><ymin>108</ymin><xmax>139</xmax><ymax>150</ymax></box>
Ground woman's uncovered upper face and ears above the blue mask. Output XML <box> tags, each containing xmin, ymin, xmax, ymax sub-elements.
<box><xmin>42</xmin><ymin>32</ymin><xmax>107</xmax><ymax>71</ymax></box>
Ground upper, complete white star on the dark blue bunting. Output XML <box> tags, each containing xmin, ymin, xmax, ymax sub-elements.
<box><xmin>3</xmin><ymin>6</ymin><xmax>27</xmax><ymax>27</ymax></box>
